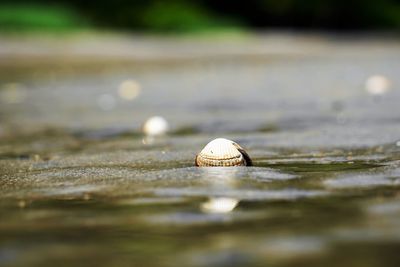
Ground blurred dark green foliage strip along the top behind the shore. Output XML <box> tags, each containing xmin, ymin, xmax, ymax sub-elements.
<box><xmin>0</xmin><ymin>0</ymin><xmax>400</xmax><ymax>33</ymax></box>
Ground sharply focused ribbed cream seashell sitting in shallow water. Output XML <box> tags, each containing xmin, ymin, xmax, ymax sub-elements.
<box><xmin>195</xmin><ymin>138</ymin><xmax>253</xmax><ymax>167</ymax></box>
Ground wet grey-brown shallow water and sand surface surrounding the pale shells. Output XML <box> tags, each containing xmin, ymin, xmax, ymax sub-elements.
<box><xmin>0</xmin><ymin>36</ymin><xmax>400</xmax><ymax>266</ymax></box>
